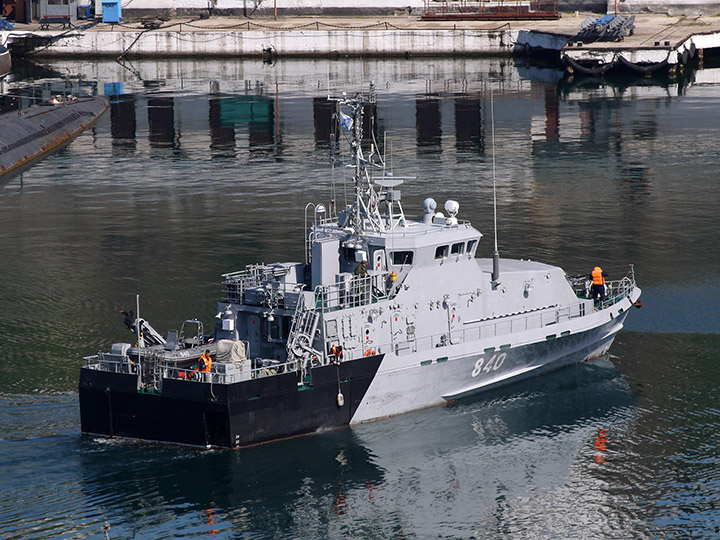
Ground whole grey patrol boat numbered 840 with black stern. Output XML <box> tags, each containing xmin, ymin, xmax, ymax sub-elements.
<box><xmin>79</xmin><ymin>91</ymin><xmax>640</xmax><ymax>448</ymax></box>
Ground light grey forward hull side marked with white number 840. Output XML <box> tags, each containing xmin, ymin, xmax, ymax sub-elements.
<box><xmin>352</xmin><ymin>288</ymin><xmax>641</xmax><ymax>424</ymax></box>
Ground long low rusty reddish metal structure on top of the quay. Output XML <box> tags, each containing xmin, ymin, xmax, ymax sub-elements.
<box><xmin>422</xmin><ymin>0</ymin><xmax>560</xmax><ymax>21</ymax></box>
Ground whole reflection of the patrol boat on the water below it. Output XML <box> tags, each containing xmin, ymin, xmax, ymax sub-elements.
<box><xmin>69</xmin><ymin>361</ymin><xmax>634</xmax><ymax>538</ymax></box>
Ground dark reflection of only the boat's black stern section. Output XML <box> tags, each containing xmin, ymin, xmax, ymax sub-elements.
<box><xmin>78</xmin><ymin>429</ymin><xmax>383</xmax><ymax>537</ymax></box>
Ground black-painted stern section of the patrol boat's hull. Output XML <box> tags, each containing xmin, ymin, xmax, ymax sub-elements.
<box><xmin>79</xmin><ymin>355</ymin><xmax>383</xmax><ymax>448</ymax></box>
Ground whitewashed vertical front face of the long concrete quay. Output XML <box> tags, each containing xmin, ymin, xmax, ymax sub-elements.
<box><xmin>22</xmin><ymin>27</ymin><xmax>567</xmax><ymax>59</ymax></box>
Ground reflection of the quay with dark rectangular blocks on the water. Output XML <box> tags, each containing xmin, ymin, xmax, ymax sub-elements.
<box><xmin>12</xmin><ymin>59</ymin><xmax>720</xmax><ymax>171</ymax></box>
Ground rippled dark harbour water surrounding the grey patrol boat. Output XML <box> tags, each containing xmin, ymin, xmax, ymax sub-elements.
<box><xmin>0</xmin><ymin>59</ymin><xmax>720</xmax><ymax>540</ymax></box>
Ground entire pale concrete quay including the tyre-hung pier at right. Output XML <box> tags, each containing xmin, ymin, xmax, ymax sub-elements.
<box><xmin>0</xmin><ymin>12</ymin><xmax>720</xmax><ymax>64</ymax></box>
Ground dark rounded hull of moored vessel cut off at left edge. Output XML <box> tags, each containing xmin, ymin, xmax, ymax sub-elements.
<box><xmin>0</xmin><ymin>96</ymin><xmax>109</xmax><ymax>178</ymax></box>
